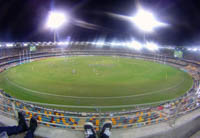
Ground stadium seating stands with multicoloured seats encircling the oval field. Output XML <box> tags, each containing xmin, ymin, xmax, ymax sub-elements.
<box><xmin>0</xmin><ymin>43</ymin><xmax>200</xmax><ymax>137</ymax></box>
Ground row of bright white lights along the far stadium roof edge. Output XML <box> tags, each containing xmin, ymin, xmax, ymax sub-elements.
<box><xmin>3</xmin><ymin>40</ymin><xmax>200</xmax><ymax>52</ymax></box>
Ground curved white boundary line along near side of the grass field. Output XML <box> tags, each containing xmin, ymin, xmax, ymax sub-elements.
<box><xmin>4</xmin><ymin>77</ymin><xmax>185</xmax><ymax>99</ymax></box>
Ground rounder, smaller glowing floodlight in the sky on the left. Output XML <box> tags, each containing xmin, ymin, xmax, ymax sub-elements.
<box><xmin>47</xmin><ymin>11</ymin><xmax>67</xmax><ymax>29</ymax></box>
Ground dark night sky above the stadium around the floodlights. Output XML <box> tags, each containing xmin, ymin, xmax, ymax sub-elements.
<box><xmin>0</xmin><ymin>0</ymin><xmax>200</xmax><ymax>46</ymax></box>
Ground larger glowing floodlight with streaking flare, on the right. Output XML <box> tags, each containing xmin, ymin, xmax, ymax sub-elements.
<box><xmin>132</xmin><ymin>8</ymin><xmax>167</xmax><ymax>32</ymax></box>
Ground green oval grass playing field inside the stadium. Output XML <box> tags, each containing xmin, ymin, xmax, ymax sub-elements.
<box><xmin>0</xmin><ymin>56</ymin><xmax>192</xmax><ymax>110</ymax></box>
